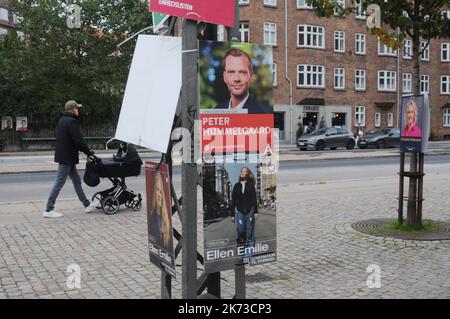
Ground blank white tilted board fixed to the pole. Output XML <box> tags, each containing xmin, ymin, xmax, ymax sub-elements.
<box><xmin>115</xmin><ymin>35</ymin><xmax>181</xmax><ymax>153</ymax></box>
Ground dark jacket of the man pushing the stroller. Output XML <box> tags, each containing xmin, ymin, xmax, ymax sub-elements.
<box><xmin>55</xmin><ymin>112</ymin><xmax>93</xmax><ymax>165</ymax></box>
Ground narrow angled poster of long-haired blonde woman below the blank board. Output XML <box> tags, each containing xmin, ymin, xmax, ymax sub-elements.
<box><xmin>145</xmin><ymin>162</ymin><xmax>176</xmax><ymax>278</ymax></box>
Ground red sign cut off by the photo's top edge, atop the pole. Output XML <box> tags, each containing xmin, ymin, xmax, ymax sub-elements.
<box><xmin>149</xmin><ymin>0</ymin><xmax>235</xmax><ymax>27</ymax></box>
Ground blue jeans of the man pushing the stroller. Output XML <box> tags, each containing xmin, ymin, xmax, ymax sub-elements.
<box><xmin>47</xmin><ymin>164</ymin><xmax>90</xmax><ymax>211</ymax></box>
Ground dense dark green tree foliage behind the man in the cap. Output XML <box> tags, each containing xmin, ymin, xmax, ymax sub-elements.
<box><xmin>0</xmin><ymin>0</ymin><xmax>151</xmax><ymax>127</ymax></box>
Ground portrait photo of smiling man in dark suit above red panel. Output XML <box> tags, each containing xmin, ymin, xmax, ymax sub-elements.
<box><xmin>199</xmin><ymin>41</ymin><xmax>273</xmax><ymax>114</ymax></box>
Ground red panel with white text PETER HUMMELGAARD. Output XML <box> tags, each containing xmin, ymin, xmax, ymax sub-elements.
<box><xmin>200</xmin><ymin>113</ymin><xmax>274</xmax><ymax>154</ymax></box>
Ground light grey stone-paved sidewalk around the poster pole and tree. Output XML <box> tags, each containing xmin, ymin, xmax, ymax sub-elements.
<box><xmin>0</xmin><ymin>149</ymin><xmax>450</xmax><ymax>299</ymax></box>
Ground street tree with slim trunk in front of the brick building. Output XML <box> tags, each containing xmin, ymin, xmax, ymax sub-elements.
<box><xmin>306</xmin><ymin>0</ymin><xmax>450</xmax><ymax>229</ymax></box>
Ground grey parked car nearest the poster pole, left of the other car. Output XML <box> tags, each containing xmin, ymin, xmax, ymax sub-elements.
<box><xmin>297</xmin><ymin>127</ymin><xmax>355</xmax><ymax>151</ymax></box>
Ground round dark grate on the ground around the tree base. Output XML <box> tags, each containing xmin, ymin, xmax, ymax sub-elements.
<box><xmin>352</xmin><ymin>218</ymin><xmax>450</xmax><ymax>240</ymax></box>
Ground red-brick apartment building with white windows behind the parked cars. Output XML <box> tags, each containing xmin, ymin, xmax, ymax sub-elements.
<box><xmin>239</xmin><ymin>0</ymin><xmax>450</xmax><ymax>142</ymax></box>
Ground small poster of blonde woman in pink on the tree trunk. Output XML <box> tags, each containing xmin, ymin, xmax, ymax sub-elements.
<box><xmin>400</xmin><ymin>95</ymin><xmax>426</xmax><ymax>153</ymax></box>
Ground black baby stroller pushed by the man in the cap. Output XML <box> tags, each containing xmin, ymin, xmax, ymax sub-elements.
<box><xmin>84</xmin><ymin>143</ymin><xmax>142</xmax><ymax>215</ymax></box>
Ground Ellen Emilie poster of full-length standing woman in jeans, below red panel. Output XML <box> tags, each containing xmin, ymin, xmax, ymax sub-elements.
<box><xmin>203</xmin><ymin>156</ymin><xmax>277</xmax><ymax>272</ymax></box>
